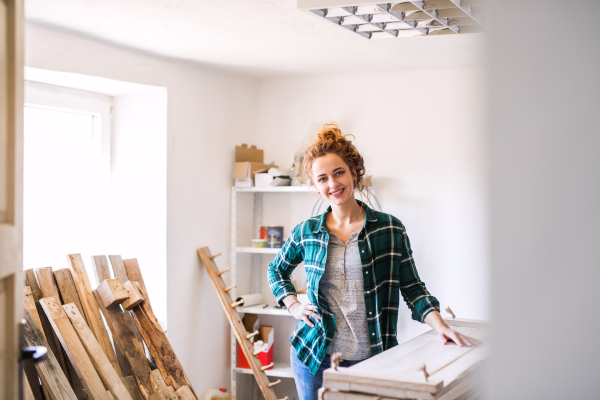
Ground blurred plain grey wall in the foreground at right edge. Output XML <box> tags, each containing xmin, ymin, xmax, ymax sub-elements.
<box><xmin>488</xmin><ymin>0</ymin><xmax>600</xmax><ymax>399</ymax></box>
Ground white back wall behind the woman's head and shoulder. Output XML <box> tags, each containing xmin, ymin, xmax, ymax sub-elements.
<box><xmin>257</xmin><ymin>65</ymin><xmax>489</xmax><ymax>341</ymax></box>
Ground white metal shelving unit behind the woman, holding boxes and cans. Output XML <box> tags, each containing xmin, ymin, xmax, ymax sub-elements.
<box><xmin>229</xmin><ymin>186</ymin><xmax>314</xmax><ymax>400</ymax></box>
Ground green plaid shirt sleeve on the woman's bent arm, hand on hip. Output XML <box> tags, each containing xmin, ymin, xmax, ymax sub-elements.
<box><xmin>267</xmin><ymin>226</ymin><xmax>303</xmax><ymax>306</ymax></box>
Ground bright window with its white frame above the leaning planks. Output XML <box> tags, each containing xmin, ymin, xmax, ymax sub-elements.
<box><xmin>23</xmin><ymin>82</ymin><xmax>111</xmax><ymax>279</ymax></box>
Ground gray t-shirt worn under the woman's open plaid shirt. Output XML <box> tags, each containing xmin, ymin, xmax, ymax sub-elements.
<box><xmin>319</xmin><ymin>233</ymin><xmax>371</xmax><ymax>360</ymax></box>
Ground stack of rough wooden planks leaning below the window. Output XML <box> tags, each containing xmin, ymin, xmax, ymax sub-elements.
<box><xmin>24</xmin><ymin>254</ymin><xmax>197</xmax><ymax>400</ymax></box>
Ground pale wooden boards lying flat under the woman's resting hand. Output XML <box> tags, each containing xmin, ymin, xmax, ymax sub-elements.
<box><xmin>321</xmin><ymin>320</ymin><xmax>488</xmax><ymax>400</ymax></box>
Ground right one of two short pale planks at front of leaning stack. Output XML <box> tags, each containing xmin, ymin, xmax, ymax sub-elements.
<box><xmin>62</xmin><ymin>303</ymin><xmax>132</xmax><ymax>400</ymax></box>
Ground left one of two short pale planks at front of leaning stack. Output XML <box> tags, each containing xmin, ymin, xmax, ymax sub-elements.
<box><xmin>40</xmin><ymin>298</ymin><xmax>109</xmax><ymax>400</ymax></box>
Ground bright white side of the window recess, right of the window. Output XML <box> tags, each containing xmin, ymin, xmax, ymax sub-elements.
<box><xmin>107</xmin><ymin>88</ymin><xmax>168</xmax><ymax>329</ymax></box>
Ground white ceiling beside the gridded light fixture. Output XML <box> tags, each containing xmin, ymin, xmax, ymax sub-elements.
<box><xmin>25</xmin><ymin>0</ymin><xmax>484</xmax><ymax>75</ymax></box>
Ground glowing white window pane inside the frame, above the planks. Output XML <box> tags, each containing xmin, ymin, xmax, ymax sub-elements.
<box><xmin>23</xmin><ymin>106</ymin><xmax>107</xmax><ymax>276</ymax></box>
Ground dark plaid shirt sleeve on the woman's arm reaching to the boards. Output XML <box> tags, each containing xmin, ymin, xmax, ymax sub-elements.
<box><xmin>400</xmin><ymin>226</ymin><xmax>440</xmax><ymax>322</ymax></box>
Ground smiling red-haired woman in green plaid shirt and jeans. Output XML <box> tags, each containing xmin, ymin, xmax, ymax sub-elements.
<box><xmin>268</xmin><ymin>124</ymin><xmax>475</xmax><ymax>400</ymax></box>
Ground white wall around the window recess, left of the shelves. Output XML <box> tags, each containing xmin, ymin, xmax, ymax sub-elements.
<box><xmin>25</xmin><ymin>24</ymin><xmax>257</xmax><ymax>392</ymax></box>
